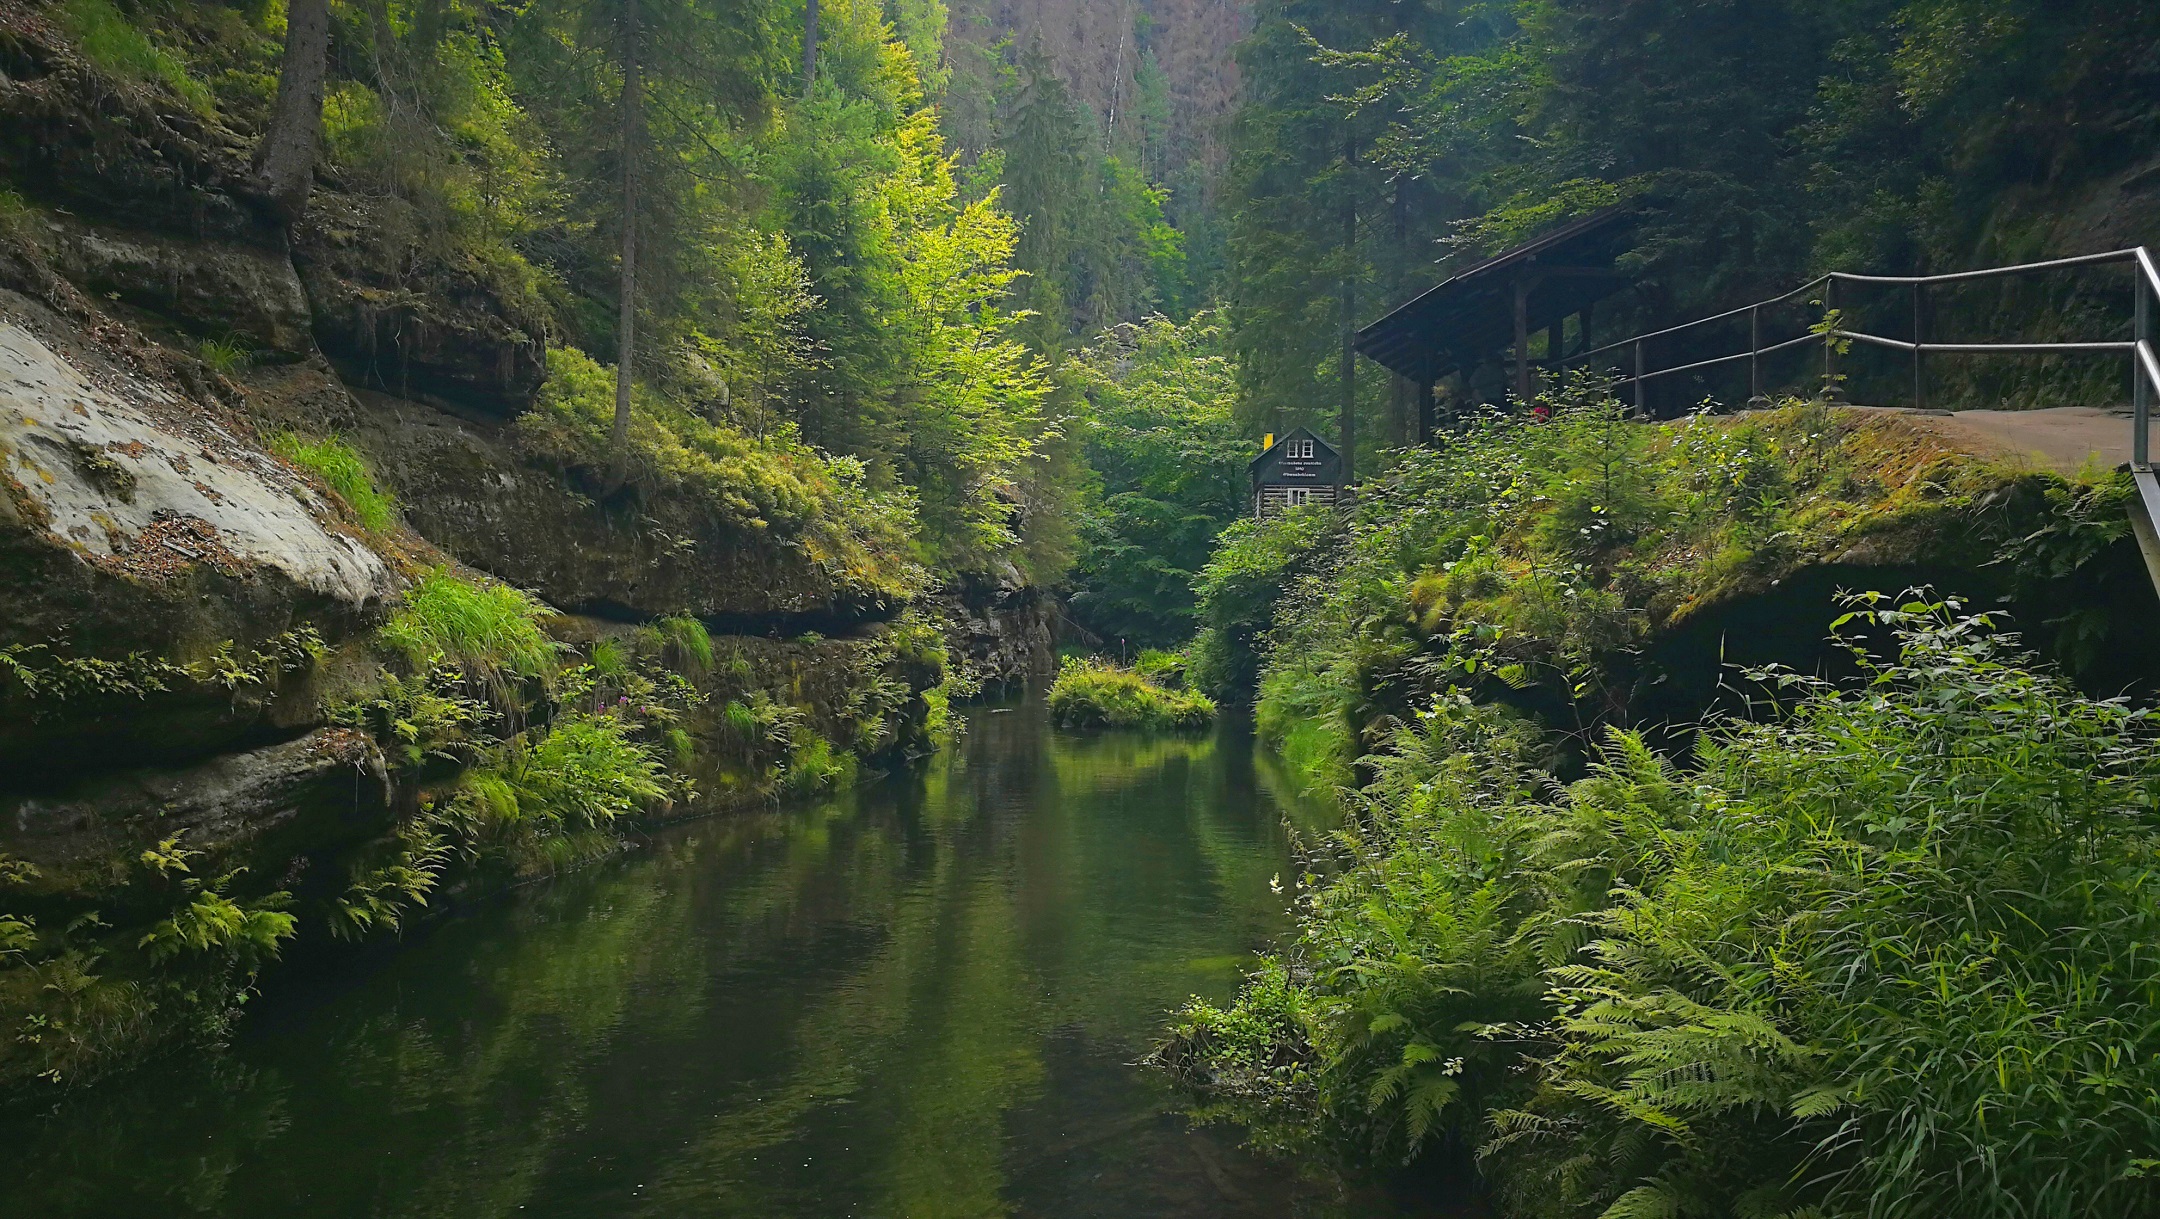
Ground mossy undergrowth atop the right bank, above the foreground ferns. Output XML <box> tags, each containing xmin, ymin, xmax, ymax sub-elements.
<box><xmin>1235</xmin><ymin>380</ymin><xmax>2128</xmax><ymax>787</ymax></box>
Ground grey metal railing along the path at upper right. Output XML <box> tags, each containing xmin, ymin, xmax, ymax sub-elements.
<box><xmin>1540</xmin><ymin>246</ymin><xmax>2160</xmax><ymax>473</ymax></box>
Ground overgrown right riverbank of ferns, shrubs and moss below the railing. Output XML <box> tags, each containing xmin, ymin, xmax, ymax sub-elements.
<box><xmin>1158</xmin><ymin>396</ymin><xmax>2160</xmax><ymax>1219</ymax></box>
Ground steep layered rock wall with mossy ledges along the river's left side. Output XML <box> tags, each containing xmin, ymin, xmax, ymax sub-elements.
<box><xmin>0</xmin><ymin>11</ymin><xmax>972</xmax><ymax>1087</ymax></box>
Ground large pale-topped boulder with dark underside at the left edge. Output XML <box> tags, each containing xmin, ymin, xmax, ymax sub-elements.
<box><xmin>0</xmin><ymin>292</ymin><xmax>400</xmax><ymax>769</ymax></box>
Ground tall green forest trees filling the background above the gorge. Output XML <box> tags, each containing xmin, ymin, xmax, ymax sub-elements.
<box><xmin>16</xmin><ymin>0</ymin><xmax>2160</xmax><ymax>644</ymax></box>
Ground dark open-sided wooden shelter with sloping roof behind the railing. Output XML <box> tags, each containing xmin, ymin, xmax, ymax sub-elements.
<box><xmin>1356</xmin><ymin>205</ymin><xmax>1637</xmax><ymax>439</ymax></box>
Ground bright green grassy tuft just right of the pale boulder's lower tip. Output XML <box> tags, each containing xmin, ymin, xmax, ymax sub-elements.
<box><xmin>378</xmin><ymin>566</ymin><xmax>562</xmax><ymax>687</ymax></box>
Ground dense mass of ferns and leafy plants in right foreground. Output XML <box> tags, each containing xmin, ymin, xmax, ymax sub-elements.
<box><xmin>1162</xmin><ymin>603</ymin><xmax>2160</xmax><ymax>1217</ymax></box>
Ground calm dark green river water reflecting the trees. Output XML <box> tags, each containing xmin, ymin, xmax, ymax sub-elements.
<box><xmin>0</xmin><ymin>705</ymin><xmax>1468</xmax><ymax>1219</ymax></box>
